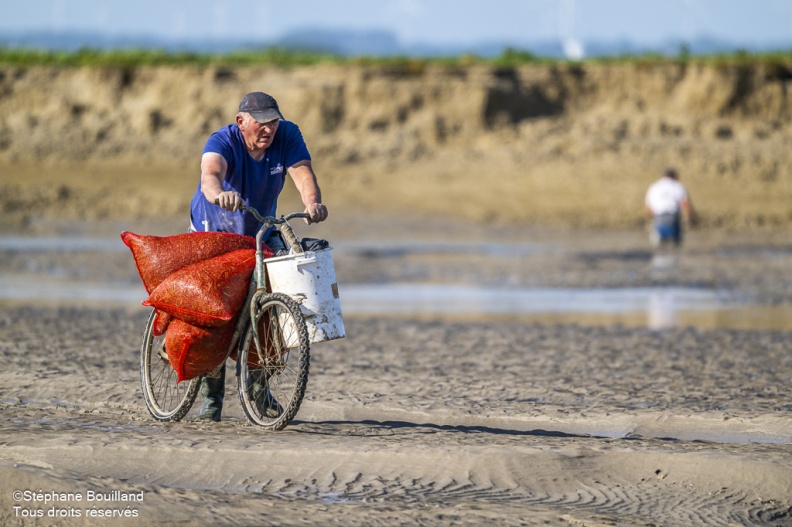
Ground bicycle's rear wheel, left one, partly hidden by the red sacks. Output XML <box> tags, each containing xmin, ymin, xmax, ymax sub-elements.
<box><xmin>140</xmin><ymin>310</ymin><xmax>201</xmax><ymax>421</ymax></box>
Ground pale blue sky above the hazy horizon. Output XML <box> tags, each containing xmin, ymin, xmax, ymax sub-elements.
<box><xmin>0</xmin><ymin>0</ymin><xmax>792</xmax><ymax>47</ymax></box>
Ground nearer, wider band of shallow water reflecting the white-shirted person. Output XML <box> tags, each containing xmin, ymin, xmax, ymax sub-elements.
<box><xmin>0</xmin><ymin>276</ymin><xmax>792</xmax><ymax>329</ymax></box>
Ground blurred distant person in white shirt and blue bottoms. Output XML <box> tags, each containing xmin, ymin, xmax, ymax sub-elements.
<box><xmin>645</xmin><ymin>168</ymin><xmax>696</xmax><ymax>247</ymax></box>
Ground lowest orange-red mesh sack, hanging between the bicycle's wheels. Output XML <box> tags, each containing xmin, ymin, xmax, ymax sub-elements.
<box><xmin>165</xmin><ymin>318</ymin><xmax>235</xmax><ymax>382</ymax></box>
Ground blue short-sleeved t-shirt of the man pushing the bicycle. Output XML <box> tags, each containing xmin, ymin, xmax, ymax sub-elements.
<box><xmin>190</xmin><ymin>120</ymin><xmax>311</xmax><ymax>240</ymax></box>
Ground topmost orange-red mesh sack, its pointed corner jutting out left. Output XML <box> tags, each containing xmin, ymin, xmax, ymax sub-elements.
<box><xmin>121</xmin><ymin>232</ymin><xmax>258</xmax><ymax>293</ymax></box>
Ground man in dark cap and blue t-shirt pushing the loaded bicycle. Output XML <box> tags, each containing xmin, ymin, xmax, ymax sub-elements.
<box><xmin>190</xmin><ymin>92</ymin><xmax>327</xmax><ymax>421</ymax></box>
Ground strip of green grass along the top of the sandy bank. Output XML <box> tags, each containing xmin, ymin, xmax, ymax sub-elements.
<box><xmin>0</xmin><ymin>46</ymin><xmax>792</xmax><ymax>70</ymax></box>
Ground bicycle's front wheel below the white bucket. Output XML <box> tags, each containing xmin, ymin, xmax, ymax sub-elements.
<box><xmin>237</xmin><ymin>293</ymin><xmax>310</xmax><ymax>430</ymax></box>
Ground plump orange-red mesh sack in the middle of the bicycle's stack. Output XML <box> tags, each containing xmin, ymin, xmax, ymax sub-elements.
<box><xmin>143</xmin><ymin>249</ymin><xmax>256</xmax><ymax>327</ymax></box>
